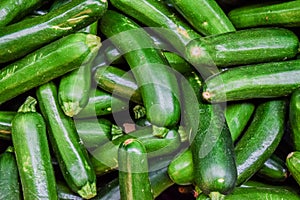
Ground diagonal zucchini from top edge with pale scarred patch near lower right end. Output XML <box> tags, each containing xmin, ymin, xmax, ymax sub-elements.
<box><xmin>110</xmin><ymin>0</ymin><xmax>200</xmax><ymax>53</ymax></box>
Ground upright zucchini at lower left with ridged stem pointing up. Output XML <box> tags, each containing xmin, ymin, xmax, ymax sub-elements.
<box><xmin>12</xmin><ymin>96</ymin><xmax>57</xmax><ymax>200</ymax></box>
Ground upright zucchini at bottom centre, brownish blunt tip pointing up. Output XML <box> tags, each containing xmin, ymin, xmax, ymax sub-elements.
<box><xmin>118</xmin><ymin>139</ymin><xmax>154</xmax><ymax>200</ymax></box>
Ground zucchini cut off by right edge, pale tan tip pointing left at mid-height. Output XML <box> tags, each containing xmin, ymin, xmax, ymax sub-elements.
<box><xmin>202</xmin><ymin>60</ymin><xmax>300</xmax><ymax>102</ymax></box>
